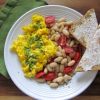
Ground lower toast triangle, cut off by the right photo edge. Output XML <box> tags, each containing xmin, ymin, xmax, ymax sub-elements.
<box><xmin>75</xmin><ymin>27</ymin><xmax>100</xmax><ymax>72</ymax></box>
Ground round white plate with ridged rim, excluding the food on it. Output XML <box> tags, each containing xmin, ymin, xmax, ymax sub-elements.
<box><xmin>4</xmin><ymin>5</ymin><xmax>97</xmax><ymax>100</ymax></box>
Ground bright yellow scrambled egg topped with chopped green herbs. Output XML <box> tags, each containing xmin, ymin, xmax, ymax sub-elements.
<box><xmin>11</xmin><ymin>15</ymin><xmax>57</xmax><ymax>78</ymax></box>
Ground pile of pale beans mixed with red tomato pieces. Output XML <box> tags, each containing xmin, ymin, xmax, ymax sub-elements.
<box><xmin>35</xmin><ymin>16</ymin><xmax>83</xmax><ymax>88</ymax></box>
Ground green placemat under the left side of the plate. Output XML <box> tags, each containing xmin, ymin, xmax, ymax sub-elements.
<box><xmin>0</xmin><ymin>0</ymin><xmax>46</xmax><ymax>78</ymax></box>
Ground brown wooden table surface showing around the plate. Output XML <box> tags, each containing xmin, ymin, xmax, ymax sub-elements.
<box><xmin>0</xmin><ymin>0</ymin><xmax>100</xmax><ymax>100</ymax></box>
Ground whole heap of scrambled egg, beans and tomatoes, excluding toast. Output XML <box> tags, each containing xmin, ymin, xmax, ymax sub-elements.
<box><xmin>11</xmin><ymin>14</ymin><xmax>84</xmax><ymax>88</ymax></box>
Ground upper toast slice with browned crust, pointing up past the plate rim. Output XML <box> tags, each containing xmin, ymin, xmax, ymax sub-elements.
<box><xmin>70</xmin><ymin>9</ymin><xmax>98</xmax><ymax>47</ymax></box>
